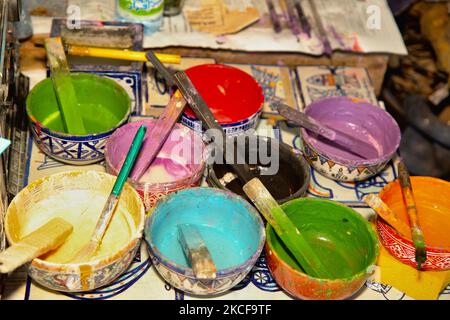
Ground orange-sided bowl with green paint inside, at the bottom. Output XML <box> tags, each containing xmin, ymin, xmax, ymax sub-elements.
<box><xmin>266</xmin><ymin>198</ymin><xmax>378</xmax><ymax>300</ymax></box>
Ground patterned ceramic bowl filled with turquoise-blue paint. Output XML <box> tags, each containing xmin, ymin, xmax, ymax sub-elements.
<box><xmin>145</xmin><ymin>188</ymin><xmax>265</xmax><ymax>296</ymax></box>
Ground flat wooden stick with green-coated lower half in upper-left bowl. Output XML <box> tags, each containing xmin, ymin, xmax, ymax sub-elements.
<box><xmin>45</xmin><ymin>38</ymin><xmax>86</xmax><ymax>135</ymax></box>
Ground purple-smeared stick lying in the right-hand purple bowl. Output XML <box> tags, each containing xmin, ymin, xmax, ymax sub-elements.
<box><xmin>272</xmin><ymin>102</ymin><xmax>378</xmax><ymax>159</ymax></box>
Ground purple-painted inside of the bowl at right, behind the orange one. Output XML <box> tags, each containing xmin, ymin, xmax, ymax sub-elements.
<box><xmin>302</xmin><ymin>97</ymin><xmax>401</xmax><ymax>167</ymax></box>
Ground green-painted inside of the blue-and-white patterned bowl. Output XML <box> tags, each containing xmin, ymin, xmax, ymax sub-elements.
<box><xmin>27</xmin><ymin>73</ymin><xmax>131</xmax><ymax>135</ymax></box>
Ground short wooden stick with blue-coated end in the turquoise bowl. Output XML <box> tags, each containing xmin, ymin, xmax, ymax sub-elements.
<box><xmin>178</xmin><ymin>224</ymin><xmax>217</xmax><ymax>280</ymax></box>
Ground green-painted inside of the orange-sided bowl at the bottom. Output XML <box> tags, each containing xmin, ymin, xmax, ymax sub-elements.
<box><xmin>266</xmin><ymin>198</ymin><xmax>378</xmax><ymax>279</ymax></box>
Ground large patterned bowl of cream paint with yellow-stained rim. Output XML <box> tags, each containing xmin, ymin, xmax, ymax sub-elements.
<box><xmin>5</xmin><ymin>171</ymin><xmax>145</xmax><ymax>292</ymax></box>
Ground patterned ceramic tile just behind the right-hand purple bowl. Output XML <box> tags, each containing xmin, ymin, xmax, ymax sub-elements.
<box><xmin>297</xmin><ymin>66</ymin><xmax>377</xmax><ymax>106</ymax></box>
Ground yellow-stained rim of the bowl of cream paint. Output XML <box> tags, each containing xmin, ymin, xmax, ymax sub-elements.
<box><xmin>5</xmin><ymin>170</ymin><xmax>145</xmax><ymax>273</ymax></box>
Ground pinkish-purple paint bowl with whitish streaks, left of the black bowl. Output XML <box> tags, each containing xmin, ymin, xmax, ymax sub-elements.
<box><xmin>105</xmin><ymin>119</ymin><xmax>205</xmax><ymax>210</ymax></box>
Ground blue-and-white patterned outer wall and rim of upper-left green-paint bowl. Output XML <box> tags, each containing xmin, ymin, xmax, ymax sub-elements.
<box><xmin>27</xmin><ymin>73</ymin><xmax>131</xmax><ymax>165</ymax></box>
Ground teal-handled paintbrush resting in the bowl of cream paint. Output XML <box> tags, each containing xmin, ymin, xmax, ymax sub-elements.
<box><xmin>69</xmin><ymin>125</ymin><xmax>147</xmax><ymax>263</ymax></box>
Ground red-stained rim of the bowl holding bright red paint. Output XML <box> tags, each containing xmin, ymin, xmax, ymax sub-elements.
<box><xmin>182</xmin><ymin>63</ymin><xmax>265</xmax><ymax>127</ymax></box>
